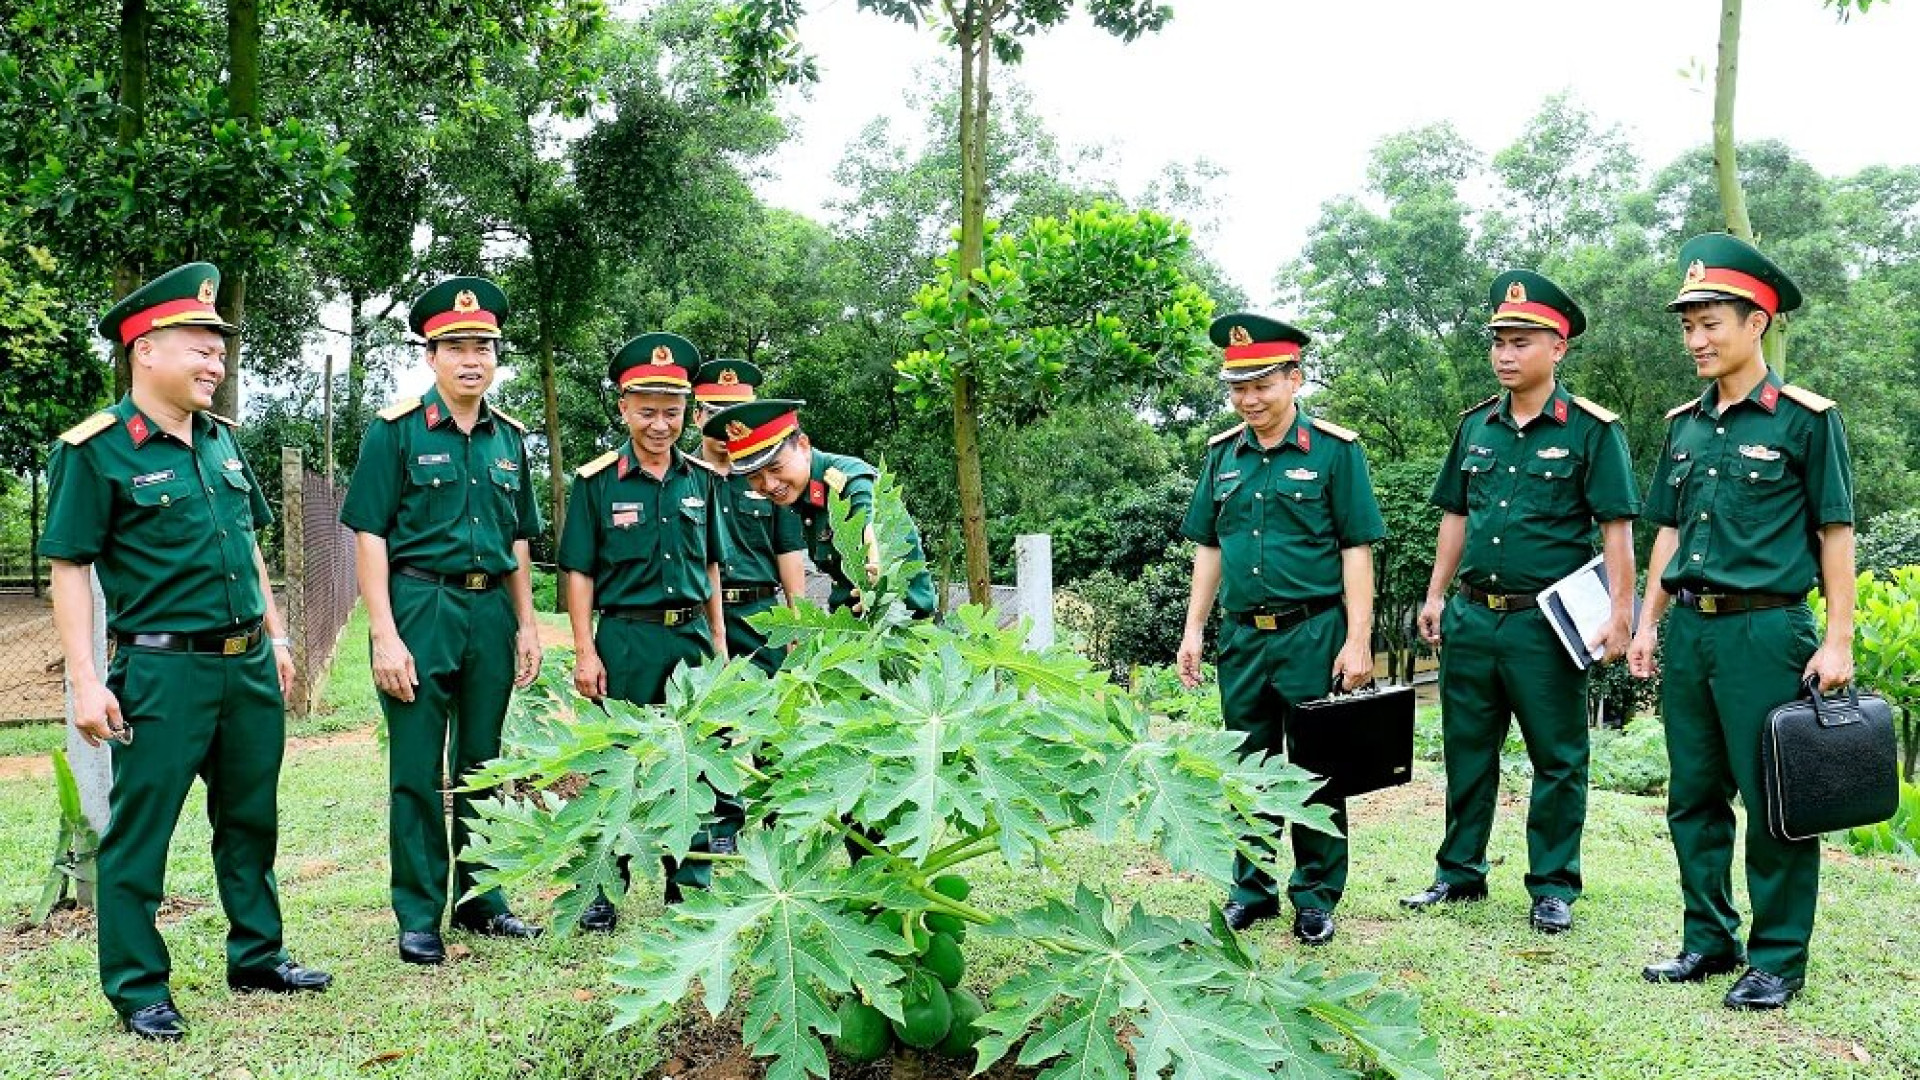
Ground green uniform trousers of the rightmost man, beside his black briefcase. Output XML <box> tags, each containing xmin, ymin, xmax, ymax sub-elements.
<box><xmin>1661</xmin><ymin>603</ymin><xmax>1820</xmax><ymax>978</ymax></box>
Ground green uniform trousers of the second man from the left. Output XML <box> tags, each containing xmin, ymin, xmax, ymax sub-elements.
<box><xmin>380</xmin><ymin>575</ymin><xmax>518</xmax><ymax>932</ymax></box>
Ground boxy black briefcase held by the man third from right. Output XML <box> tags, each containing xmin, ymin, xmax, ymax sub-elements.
<box><xmin>1286</xmin><ymin>686</ymin><xmax>1413</xmax><ymax>798</ymax></box>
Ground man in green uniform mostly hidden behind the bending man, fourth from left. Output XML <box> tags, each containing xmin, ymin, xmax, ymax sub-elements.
<box><xmin>693</xmin><ymin>359</ymin><xmax>806</xmax><ymax>675</ymax></box>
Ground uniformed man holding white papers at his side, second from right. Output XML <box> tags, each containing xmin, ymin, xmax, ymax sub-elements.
<box><xmin>1402</xmin><ymin>269</ymin><xmax>1640</xmax><ymax>934</ymax></box>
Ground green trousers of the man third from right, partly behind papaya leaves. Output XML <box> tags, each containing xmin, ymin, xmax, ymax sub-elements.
<box><xmin>1219</xmin><ymin>607</ymin><xmax>1348</xmax><ymax>911</ymax></box>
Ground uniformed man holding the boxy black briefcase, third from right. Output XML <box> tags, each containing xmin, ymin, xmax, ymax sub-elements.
<box><xmin>1177</xmin><ymin>313</ymin><xmax>1386</xmax><ymax>945</ymax></box>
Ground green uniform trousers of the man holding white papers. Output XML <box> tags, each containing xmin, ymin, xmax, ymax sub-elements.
<box><xmin>1436</xmin><ymin>596</ymin><xmax>1592</xmax><ymax>903</ymax></box>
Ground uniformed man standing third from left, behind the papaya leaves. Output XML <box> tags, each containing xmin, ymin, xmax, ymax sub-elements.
<box><xmin>557</xmin><ymin>334</ymin><xmax>743</xmax><ymax>932</ymax></box>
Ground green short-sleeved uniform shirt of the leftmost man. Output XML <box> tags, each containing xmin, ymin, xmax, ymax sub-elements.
<box><xmin>40</xmin><ymin>396</ymin><xmax>273</xmax><ymax>634</ymax></box>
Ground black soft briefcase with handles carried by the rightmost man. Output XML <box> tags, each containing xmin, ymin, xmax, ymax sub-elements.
<box><xmin>1761</xmin><ymin>678</ymin><xmax>1901</xmax><ymax>840</ymax></box>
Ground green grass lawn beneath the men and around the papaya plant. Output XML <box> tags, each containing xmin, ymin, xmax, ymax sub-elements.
<box><xmin>0</xmin><ymin>623</ymin><xmax>1920</xmax><ymax>1080</ymax></box>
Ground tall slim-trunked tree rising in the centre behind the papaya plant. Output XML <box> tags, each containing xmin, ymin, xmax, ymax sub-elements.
<box><xmin>726</xmin><ymin>0</ymin><xmax>1173</xmax><ymax>603</ymax></box>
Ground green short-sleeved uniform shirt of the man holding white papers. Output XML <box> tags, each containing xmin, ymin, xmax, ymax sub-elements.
<box><xmin>1430</xmin><ymin>382</ymin><xmax>1640</xmax><ymax>592</ymax></box>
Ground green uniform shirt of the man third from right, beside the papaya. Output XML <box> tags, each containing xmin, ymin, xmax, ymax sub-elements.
<box><xmin>1181</xmin><ymin>409</ymin><xmax>1386</xmax><ymax>613</ymax></box>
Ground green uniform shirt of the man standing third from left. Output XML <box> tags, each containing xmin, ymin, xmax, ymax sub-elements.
<box><xmin>555</xmin><ymin>444</ymin><xmax>722</xmax><ymax>607</ymax></box>
